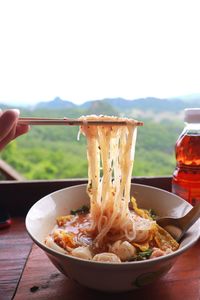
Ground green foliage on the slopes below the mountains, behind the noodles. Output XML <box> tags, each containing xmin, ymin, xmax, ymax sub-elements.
<box><xmin>1</xmin><ymin>109</ymin><xmax>182</xmax><ymax>179</ymax></box>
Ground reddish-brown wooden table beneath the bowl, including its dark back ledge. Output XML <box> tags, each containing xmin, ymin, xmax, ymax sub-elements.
<box><xmin>0</xmin><ymin>177</ymin><xmax>200</xmax><ymax>300</ymax></box>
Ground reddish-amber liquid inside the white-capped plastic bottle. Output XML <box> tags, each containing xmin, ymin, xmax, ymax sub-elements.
<box><xmin>172</xmin><ymin>131</ymin><xmax>200</xmax><ymax>205</ymax></box>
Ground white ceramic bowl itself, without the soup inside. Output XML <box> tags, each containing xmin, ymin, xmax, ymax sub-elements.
<box><xmin>26</xmin><ymin>184</ymin><xmax>200</xmax><ymax>292</ymax></box>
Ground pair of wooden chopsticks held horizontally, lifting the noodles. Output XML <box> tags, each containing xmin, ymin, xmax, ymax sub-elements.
<box><xmin>18</xmin><ymin>118</ymin><xmax>143</xmax><ymax>126</ymax></box>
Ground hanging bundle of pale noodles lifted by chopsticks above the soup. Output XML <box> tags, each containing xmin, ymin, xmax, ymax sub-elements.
<box><xmin>80</xmin><ymin>115</ymin><xmax>137</xmax><ymax>247</ymax></box>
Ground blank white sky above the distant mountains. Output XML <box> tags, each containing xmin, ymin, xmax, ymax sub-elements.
<box><xmin>0</xmin><ymin>0</ymin><xmax>200</xmax><ymax>105</ymax></box>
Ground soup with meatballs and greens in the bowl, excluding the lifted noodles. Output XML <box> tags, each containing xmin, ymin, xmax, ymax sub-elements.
<box><xmin>45</xmin><ymin>200</ymin><xmax>179</xmax><ymax>263</ymax></box>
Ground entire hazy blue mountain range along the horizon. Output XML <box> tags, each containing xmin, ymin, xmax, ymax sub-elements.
<box><xmin>0</xmin><ymin>94</ymin><xmax>200</xmax><ymax>119</ymax></box>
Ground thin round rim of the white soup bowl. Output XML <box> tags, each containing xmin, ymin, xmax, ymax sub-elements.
<box><xmin>25</xmin><ymin>183</ymin><xmax>200</xmax><ymax>269</ymax></box>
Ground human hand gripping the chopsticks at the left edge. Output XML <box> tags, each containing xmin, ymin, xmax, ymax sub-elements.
<box><xmin>0</xmin><ymin>109</ymin><xmax>29</xmax><ymax>150</ymax></box>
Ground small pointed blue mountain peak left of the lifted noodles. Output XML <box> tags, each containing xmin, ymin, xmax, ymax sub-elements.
<box><xmin>35</xmin><ymin>97</ymin><xmax>76</xmax><ymax>109</ymax></box>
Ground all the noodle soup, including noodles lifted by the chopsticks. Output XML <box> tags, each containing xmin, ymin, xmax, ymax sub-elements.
<box><xmin>45</xmin><ymin>116</ymin><xmax>179</xmax><ymax>263</ymax></box>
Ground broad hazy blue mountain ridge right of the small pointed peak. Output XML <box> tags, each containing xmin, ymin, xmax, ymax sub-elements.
<box><xmin>76</xmin><ymin>97</ymin><xmax>200</xmax><ymax>122</ymax></box>
